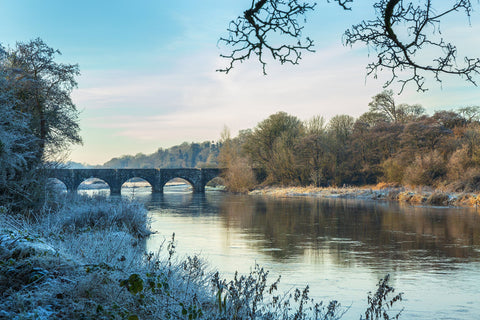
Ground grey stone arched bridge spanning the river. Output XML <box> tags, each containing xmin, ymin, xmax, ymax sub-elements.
<box><xmin>47</xmin><ymin>168</ymin><xmax>222</xmax><ymax>194</ymax></box>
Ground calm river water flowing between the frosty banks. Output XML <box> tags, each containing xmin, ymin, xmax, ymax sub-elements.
<box><xmin>91</xmin><ymin>185</ymin><xmax>480</xmax><ymax>320</ymax></box>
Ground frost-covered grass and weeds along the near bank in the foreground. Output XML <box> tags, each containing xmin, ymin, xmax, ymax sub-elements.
<box><xmin>0</xmin><ymin>197</ymin><xmax>404</xmax><ymax>320</ymax></box>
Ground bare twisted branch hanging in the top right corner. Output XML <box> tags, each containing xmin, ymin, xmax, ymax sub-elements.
<box><xmin>345</xmin><ymin>0</ymin><xmax>480</xmax><ymax>92</ymax></box>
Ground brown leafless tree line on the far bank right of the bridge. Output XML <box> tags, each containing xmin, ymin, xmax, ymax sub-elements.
<box><xmin>219</xmin><ymin>91</ymin><xmax>480</xmax><ymax>192</ymax></box>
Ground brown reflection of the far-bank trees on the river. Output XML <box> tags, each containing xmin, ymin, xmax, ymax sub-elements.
<box><xmin>215</xmin><ymin>196</ymin><xmax>480</xmax><ymax>268</ymax></box>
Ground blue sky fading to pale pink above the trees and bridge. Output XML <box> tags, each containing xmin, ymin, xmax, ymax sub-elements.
<box><xmin>0</xmin><ymin>0</ymin><xmax>480</xmax><ymax>164</ymax></box>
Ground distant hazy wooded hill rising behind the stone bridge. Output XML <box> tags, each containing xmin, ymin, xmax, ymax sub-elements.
<box><xmin>101</xmin><ymin>141</ymin><xmax>220</xmax><ymax>169</ymax></box>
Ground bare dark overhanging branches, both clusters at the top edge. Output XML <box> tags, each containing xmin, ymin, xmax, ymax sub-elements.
<box><xmin>218</xmin><ymin>0</ymin><xmax>480</xmax><ymax>91</ymax></box>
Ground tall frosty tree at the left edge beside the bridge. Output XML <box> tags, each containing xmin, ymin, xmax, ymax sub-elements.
<box><xmin>0</xmin><ymin>39</ymin><xmax>82</xmax><ymax>210</ymax></box>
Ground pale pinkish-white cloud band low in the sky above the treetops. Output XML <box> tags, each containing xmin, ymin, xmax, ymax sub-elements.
<box><xmin>74</xmin><ymin>37</ymin><xmax>480</xmax><ymax>159</ymax></box>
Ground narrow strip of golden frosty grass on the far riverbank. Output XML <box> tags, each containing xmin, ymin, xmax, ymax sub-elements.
<box><xmin>249</xmin><ymin>184</ymin><xmax>480</xmax><ymax>207</ymax></box>
